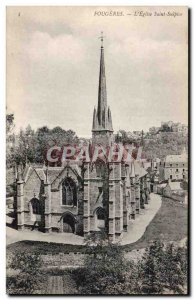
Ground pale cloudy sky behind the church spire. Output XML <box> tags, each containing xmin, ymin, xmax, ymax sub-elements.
<box><xmin>7</xmin><ymin>7</ymin><xmax>188</xmax><ymax>136</ymax></box>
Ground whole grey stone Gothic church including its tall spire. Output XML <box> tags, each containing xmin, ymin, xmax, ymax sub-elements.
<box><xmin>16</xmin><ymin>41</ymin><xmax>150</xmax><ymax>241</ymax></box>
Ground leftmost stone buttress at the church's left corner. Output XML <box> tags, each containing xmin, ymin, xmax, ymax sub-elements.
<box><xmin>17</xmin><ymin>178</ymin><xmax>24</xmax><ymax>230</ymax></box>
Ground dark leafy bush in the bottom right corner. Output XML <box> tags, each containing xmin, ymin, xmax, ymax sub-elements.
<box><xmin>140</xmin><ymin>241</ymin><xmax>187</xmax><ymax>294</ymax></box>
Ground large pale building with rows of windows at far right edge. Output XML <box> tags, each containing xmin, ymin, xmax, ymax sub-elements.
<box><xmin>159</xmin><ymin>149</ymin><xmax>188</xmax><ymax>181</ymax></box>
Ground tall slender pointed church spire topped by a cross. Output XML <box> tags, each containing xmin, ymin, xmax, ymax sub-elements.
<box><xmin>92</xmin><ymin>32</ymin><xmax>113</xmax><ymax>131</ymax></box>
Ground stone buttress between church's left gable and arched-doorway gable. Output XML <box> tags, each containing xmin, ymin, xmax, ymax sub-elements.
<box><xmin>44</xmin><ymin>182</ymin><xmax>52</xmax><ymax>232</ymax></box>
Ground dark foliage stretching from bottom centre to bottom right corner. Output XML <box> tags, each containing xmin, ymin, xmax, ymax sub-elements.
<box><xmin>74</xmin><ymin>237</ymin><xmax>187</xmax><ymax>295</ymax></box>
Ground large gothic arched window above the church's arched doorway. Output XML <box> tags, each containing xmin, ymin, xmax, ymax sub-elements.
<box><xmin>62</xmin><ymin>177</ymin><xmax>77</xmax><ymax>206</ymax></box>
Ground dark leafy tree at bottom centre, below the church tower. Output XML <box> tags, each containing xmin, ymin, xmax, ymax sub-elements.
<box><xmin>76</xmin><ymin>236</ymin><xmax>128</xmax><ymax>295</ymax></box>
